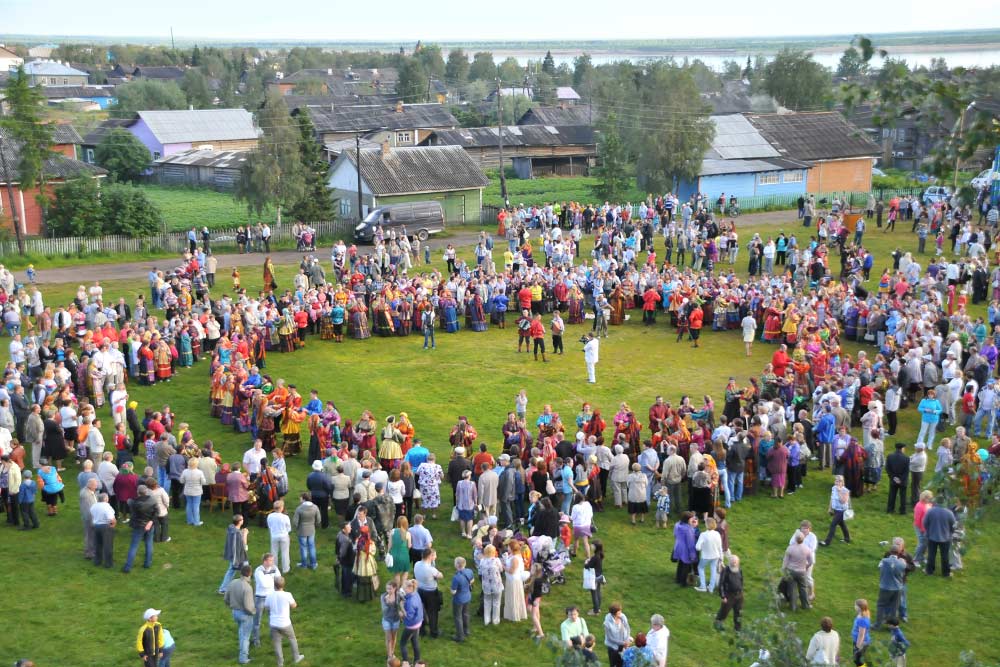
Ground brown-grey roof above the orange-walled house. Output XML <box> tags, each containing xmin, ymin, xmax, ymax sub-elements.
<box><xmin>746</xmin><ymin>111</ymin><xmax>881</xmax><ymax>160</ymax></box>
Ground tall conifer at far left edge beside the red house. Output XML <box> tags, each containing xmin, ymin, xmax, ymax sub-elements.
<box><xmin>0</xmin><ymin>65</ymin><xmax>52</xmax><ymax>254</ymax></box>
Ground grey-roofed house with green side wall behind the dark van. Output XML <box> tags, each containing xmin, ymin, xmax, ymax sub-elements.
<box><xmin>328</xmin><ymin>141</ymin><xmax>489</xmax><ymax>224</ymax></box>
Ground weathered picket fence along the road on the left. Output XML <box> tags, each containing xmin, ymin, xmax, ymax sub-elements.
<box><xmin>0</xmin><ymin>220</ymin><xmax>356</xmax><ymax>257</ymax></box>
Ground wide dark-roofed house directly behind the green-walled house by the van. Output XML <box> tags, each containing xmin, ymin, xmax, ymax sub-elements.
<box><xmin>292</xmin><ymin>102</ymin><xmax>459</xmax><ymax>146</ymax></box>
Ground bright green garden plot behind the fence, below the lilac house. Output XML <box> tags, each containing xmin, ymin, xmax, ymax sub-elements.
<box><xmin>140</xmin><ymin>185</ymin><xmax>274</xmax><ymax>232</ymax></box>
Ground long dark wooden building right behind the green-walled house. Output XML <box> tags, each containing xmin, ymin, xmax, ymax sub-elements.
<box><xmin>423</xmin><ymin>125</ymin><xmax>597</xmax><ymax>178</ymax></box>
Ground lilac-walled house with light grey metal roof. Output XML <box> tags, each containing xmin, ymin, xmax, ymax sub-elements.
<box><xmin>126</xmin><ymin>109</ymin><xmax>260</xmax><ymax>161</ymax></box>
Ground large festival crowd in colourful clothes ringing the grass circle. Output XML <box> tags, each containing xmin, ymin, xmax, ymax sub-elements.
<box><xmin>0</xmin><ymin>187</ymin><xmax>1000</xmax><ymax>667</ymax></box>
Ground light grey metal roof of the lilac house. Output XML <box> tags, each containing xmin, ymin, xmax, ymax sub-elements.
<box><xmin>139</xmin><ymin>109</ymin><xmax>260</xmax><ymax>144</ymax></box>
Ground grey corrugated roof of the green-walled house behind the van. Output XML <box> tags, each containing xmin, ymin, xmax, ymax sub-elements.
<box><xmin>341</xmin><ymin>146</ymin><xmax>490</xmax><ymax>196</ymax></box>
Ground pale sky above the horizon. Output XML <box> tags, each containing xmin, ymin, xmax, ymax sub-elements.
<box><xmin>0</xmin><ymin>0</ymin><xmax>1000</xmax><ymax>43</ymax></box>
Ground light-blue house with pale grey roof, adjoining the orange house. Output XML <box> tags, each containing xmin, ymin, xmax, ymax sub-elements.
<box><xmin>677</xmin><ymin>114</ymin><xmax>812</xmax><ymax>201</ymax></box>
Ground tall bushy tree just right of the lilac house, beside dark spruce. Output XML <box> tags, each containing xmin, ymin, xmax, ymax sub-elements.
<box><xmin>234</xmin><ymin>93</ymin><xmax>306</xmax><ymax>225</ymax></box>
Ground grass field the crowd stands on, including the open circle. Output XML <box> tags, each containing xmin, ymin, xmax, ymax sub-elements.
<box><xmin>9</xmin><ymin>214</ymin><xmax>1000</xmax><ymax>667</ymax></box>
